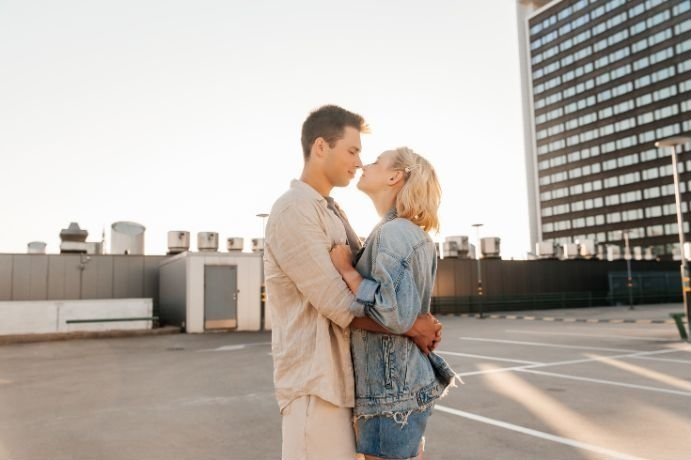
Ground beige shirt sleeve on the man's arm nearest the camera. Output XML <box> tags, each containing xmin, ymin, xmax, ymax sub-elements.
<box><xmin>266</xmin><ymin>202</ymin><xmax>354</xmax><ymax>328</ymax></box>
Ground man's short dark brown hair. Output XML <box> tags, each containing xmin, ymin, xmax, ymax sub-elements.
<box><xmin>302</xmin><ymin>105</ymin><xmax>368</xmax><ymax>161</ymax></box>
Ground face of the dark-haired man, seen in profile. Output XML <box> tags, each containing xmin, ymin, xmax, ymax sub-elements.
<box><xmin>324</xmin><ymin>126</ymin><xmax>362</xmax><ymax>187</ymax></box>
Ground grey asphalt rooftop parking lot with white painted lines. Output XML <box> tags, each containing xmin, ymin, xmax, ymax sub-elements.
<box><xmin>0</xmin><ymin>305</ymin><xmax>691</xmax><ymax>460</ymax></box>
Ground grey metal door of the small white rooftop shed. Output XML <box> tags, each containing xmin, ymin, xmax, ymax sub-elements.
<box><xmin>204</xmin><ymin>265</ymin><xmax>240</xmax><ymax>329</ymax></box>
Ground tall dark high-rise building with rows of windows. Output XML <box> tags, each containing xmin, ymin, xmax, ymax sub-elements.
<box><xmin>517</xmin><ymin>0</ymin><xmax>691</xmax><ymax>258</ymax></box>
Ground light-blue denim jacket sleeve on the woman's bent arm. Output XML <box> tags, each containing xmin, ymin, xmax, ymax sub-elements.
<box><xmin>351</xmin><ymin>225</ymin><xmax>421</xmax><ymax>334</ymax></box>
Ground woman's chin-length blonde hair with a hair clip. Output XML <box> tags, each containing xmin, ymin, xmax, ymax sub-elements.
<box><xmin>391</xmin><ymin>147</ymin><xmax>441</xmax><ymax>232</ymax></box>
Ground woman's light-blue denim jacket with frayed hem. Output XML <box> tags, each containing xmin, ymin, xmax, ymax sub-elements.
<box><xmin>351</xmin><ymin>209</ymin><xmax>456</xmax><ymax>423</ymax></box>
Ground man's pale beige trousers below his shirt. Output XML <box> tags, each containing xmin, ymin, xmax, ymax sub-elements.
<box><xmin>281</xmin><ymin>396</ymin><xmax>357</xmax><ymax>460</ymax></box>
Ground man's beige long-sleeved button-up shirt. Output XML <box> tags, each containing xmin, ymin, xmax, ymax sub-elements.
<box><xmin>264</xmin><ymin>180</ymin><xmax>354</xmax><ymax>411</ymax></box>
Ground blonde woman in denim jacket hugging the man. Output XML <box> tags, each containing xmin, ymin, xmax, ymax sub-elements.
<box><xmin>331</xmin><ymin>147</ymin><xmax>457</xmax><ymax>459</ymax></box>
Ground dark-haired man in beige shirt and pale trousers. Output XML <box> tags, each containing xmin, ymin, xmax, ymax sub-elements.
<box><xmin>264</xmin><ymin>105</ymin><xmax>440</xmax><ymax>460</ymax></box>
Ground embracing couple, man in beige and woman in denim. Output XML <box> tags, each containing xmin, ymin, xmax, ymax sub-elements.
<box><xmin>264</xmin><ymin>105</ymin><xmax>457</xmax><ymax>460</ymax></box>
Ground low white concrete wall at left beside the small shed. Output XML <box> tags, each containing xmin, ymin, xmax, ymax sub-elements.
<box><xmin>0</xmin><ymin>299</ymin><xmax>153</xmax><ymax>335</ymax></box>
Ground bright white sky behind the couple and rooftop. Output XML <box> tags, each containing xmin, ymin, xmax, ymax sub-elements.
<box><xmin>0</xmin><ymin>0</ymin><xmax>531</xmax><ymax>258</ymax></box>
